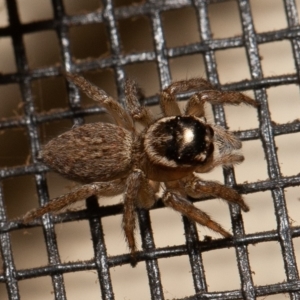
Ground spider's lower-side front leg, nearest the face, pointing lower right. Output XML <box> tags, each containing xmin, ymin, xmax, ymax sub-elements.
<box><xmin>182</xmin><ymin>175</ymin><xmax>249</xmax><ymax>212</ymax></box>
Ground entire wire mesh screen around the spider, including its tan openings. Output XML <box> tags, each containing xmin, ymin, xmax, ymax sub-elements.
<box><xmin>0</xmin><ymin>0</ymin><xmax>300</xmax><ymax>299</ymax></box>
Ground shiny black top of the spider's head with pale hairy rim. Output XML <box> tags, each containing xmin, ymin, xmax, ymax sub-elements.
<box><xmin>145</xmin><ymin>116</ymin><xmax>214</xmax><ymax>166</ymax></box>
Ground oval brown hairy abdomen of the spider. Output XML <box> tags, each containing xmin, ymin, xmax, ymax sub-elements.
<box><xmin>41</xmin><ymin>123</ymin><xmax>132</xmax><ymax>183</ymax></box>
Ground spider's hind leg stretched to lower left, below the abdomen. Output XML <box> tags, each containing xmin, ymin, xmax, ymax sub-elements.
<box><xmin>21</xmin><ymin>180</ymin><xmax>124</xmax><ymax>224</ymax></box>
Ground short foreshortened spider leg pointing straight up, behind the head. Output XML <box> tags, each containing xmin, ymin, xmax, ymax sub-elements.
<box><xmin>125</xmin><ymin>79</ymin><xmax>155</xmax><ymax>126</ymax></box>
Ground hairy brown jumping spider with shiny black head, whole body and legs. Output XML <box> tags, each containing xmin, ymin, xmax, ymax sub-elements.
<box><xmin>22</xmin><ymin>74</ymin><xmax>257</xmax><ymax>265</ymax></box>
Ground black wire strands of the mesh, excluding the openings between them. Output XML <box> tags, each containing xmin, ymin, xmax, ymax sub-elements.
<box><xmin>0</xmin><ymin>0</ymin><xmax>300</xmax><ymax>299</ymax></box>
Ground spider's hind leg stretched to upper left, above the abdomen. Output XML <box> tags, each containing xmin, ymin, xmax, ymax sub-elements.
<box><xmin>66</xmin><ymin>73</ymin><xmax>134</xmax><ymax>130</ymax></box>
